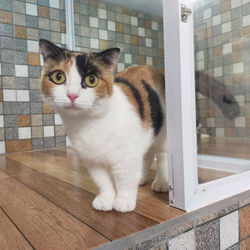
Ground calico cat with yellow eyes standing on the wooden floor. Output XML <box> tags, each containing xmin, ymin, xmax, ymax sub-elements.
<box><xmin>39</xmin><ymin>39</ymin><xmax>168</xmax><ymax>212</ymax></box>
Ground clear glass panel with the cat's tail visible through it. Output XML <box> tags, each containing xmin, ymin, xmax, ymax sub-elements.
<box><xmin>193</xmin><ymin>0</ymin><xmax>250</xmax><ymax>182</ymax></box>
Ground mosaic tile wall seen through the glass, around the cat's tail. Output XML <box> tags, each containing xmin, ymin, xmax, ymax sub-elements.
<box><xmin>194</xmin><ymin>0</ymin><xmax>250</xmax><ymax>138</ymax></box>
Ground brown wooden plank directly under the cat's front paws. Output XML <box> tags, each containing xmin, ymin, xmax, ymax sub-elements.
<box><xmin>12</xmin><ymin>168</ymin><xmax>157</xmax><ymax>240</ymax></box>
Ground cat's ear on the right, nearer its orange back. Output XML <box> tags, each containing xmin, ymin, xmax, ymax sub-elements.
<box><xmin>96</xmin><ymin>48</ymin><xmax>121</xmax><ymax>71</ymax></box>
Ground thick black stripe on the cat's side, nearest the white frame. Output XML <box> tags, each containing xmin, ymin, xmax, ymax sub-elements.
<box><xmin>141</xmin><ymin>80</ymin><xmax>163</xmax><ymax>136</ymax></box>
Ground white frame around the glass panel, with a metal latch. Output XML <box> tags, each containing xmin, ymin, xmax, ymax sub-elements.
<box><xmin>163</xmin><ymin>0</ymin><xmax>250</xmax><ymax>212</ymax></box>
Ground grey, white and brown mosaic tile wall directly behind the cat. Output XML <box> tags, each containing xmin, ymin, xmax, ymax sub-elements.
<box><xmin>0</xmin><ymin>0</ymin><xmax>163</xmax><ymax>154</ymax></box>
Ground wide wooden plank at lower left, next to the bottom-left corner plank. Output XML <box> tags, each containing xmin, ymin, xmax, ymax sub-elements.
<box><xmin>0</xmin><ymin>175</ymin><xmax>109</xmax><ymax>249</ymax></box>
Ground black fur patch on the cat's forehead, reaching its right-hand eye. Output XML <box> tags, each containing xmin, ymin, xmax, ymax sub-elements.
<box><xmin>76</xmin><ymin>53</ymin><xmax>100</xmax><ymax>89</ymax></box>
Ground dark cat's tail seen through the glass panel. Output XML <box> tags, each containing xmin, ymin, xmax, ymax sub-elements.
<box><xmin>195</xmin><ymin>72</ymin><xmax>240</xmax><ymax>120</ymax></box>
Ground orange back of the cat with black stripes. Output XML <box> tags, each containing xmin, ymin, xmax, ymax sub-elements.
<box><xmin>115</xmin><ymin>65</ymin><xmax>165</xmax><ymax>135</ymax></box>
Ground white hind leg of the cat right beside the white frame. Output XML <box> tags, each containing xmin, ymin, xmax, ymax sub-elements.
<box><xmin>152</xmin><ymin>138</ymin><xmax>168</xmax><ymax>192</ymax></box>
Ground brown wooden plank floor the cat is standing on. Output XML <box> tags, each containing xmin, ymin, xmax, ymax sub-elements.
<box><xmin>0</xmin><ymin>138</ymin><xmax>244</xmax><ymax>249</ymax></box>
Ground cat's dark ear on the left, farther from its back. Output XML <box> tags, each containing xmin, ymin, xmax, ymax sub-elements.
<box><xmin>39</xmin><ymin>39</ymin><xmax>65</xmax><ymax>62</ymax></box>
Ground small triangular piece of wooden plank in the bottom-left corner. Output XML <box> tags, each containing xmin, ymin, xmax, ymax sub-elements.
<box><xmin>0</xmin><ymin>209</ymin><xmax>32</xmax><ymax>250</ymax></box>
